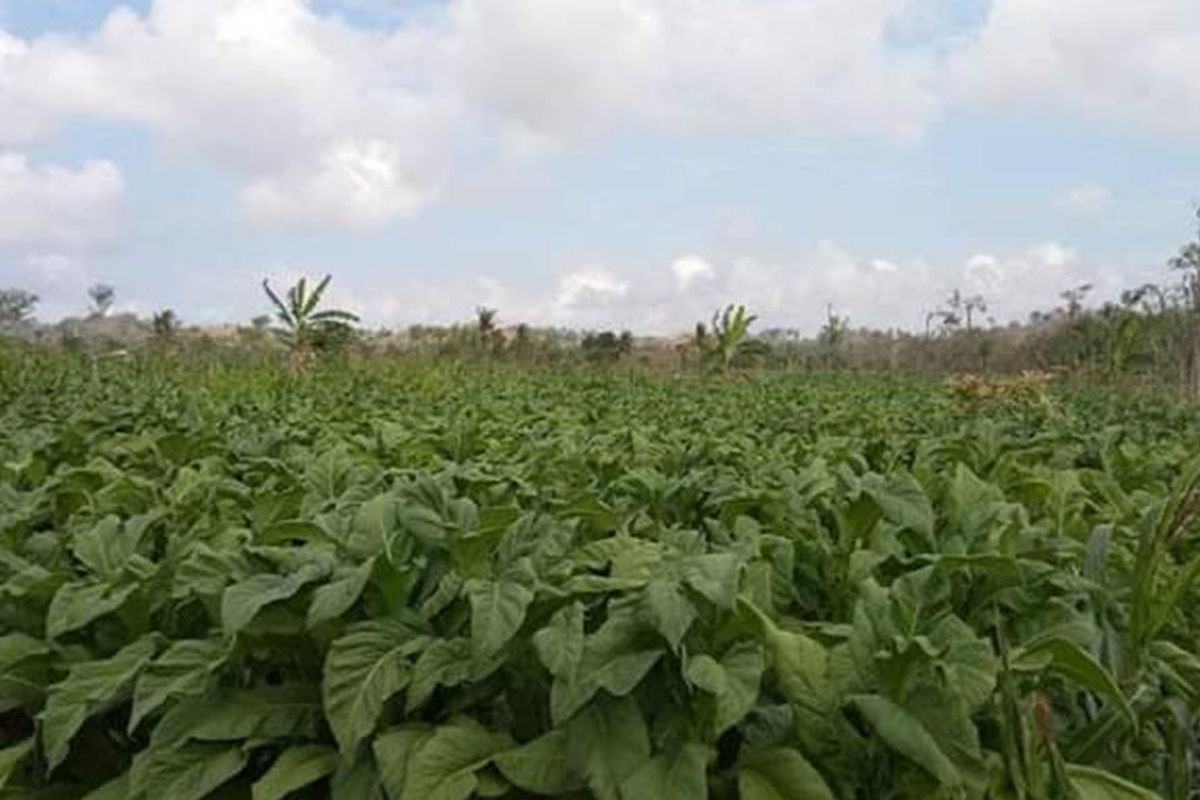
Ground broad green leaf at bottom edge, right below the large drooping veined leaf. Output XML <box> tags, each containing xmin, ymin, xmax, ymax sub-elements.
<box><xmin>400</xmin><ymin>718</ymin><xmax>512</xmax><ymax>800</ymax></box>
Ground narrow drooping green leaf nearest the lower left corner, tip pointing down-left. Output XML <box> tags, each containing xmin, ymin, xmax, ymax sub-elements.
<box><xmin>38</xmin><ymin>637</ymin><xmax>157</xmax><ymax>770</ymax></box>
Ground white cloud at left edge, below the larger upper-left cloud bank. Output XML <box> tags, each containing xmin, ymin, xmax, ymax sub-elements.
<box><xmin>0</xmin><ymin>151</ymin><xmax>125</xmax><ymax>253</ymax></box>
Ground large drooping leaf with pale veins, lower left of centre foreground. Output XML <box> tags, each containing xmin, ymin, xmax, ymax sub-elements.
<box><xmin>323</xmin><ymin>620</ymin><xmax>426</xmax><ymax>754</ymax></box>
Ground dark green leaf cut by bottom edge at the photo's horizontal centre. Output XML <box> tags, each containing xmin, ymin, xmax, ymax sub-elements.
<box><xmin>566</xmin><ymin>696</ymin><xmax>650</xmax><ymax>800</ymax></box>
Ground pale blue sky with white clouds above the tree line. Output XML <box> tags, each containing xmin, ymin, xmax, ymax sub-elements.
<box><xmin>0</xmin><ymin>0</ymin><xmax>1200</xmax><ymax>332</ymax></box>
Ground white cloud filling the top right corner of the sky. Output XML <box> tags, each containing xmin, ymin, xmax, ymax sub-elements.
<box><xmin>948</xmin><ymin>0</ymin><xmax>1200</xmax><ymax>136</ymax></box>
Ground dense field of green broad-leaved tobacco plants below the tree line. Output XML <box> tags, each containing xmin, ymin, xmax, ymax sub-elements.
<box><xmin>0</xmin><ymin>355</ymin><xmax>1200</xmax><ymax>800</ymax></box>
